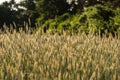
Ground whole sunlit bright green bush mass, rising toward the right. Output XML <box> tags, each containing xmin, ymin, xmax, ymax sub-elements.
<box><xmin>36</xmin><ymin>5</ymin><xmax>120</xmax><ymax>35</ymax></box>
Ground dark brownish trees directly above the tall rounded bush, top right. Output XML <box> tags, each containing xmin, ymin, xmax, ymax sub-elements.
<box><xmin>67</xmin><ymin>0</ymin><xmax>120</xmax><ymax>12</ymax></box>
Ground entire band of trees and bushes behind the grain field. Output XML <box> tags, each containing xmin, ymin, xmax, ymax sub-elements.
<box><xmin>0</xmin><ymin>0</ymin><xmax>120</xmax><ymax>34</ymax></box>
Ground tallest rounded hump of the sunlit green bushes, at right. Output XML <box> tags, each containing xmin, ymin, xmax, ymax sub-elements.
<box><xmin>80</xmin><ymin>5</ymin><xmax>114</xmax><ymax>34</ymax></box>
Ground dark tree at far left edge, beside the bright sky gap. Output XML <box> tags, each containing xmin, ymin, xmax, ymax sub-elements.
<box><xmin>0</xmin><ymin>0</ymin><xmax>15</xmax><ymax>28</ymax></box>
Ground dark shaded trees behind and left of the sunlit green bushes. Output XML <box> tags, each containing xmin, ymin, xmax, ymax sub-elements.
<box><xmin>0</xmin><ymin>0</ymin><xmax>120</xmax><ymax>34</ymax></box>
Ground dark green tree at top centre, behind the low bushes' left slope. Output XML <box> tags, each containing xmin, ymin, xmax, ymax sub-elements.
<box><xmin>36</xmin><ymin>0</ymin><xmax>70</xmax><ymax>22</ymax></box>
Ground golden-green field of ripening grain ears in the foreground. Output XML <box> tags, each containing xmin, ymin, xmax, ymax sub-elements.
<box><xmin>0</xmin><ymin>30</ymin><xmax>120</xmax><ymax>80</ymax></box>
